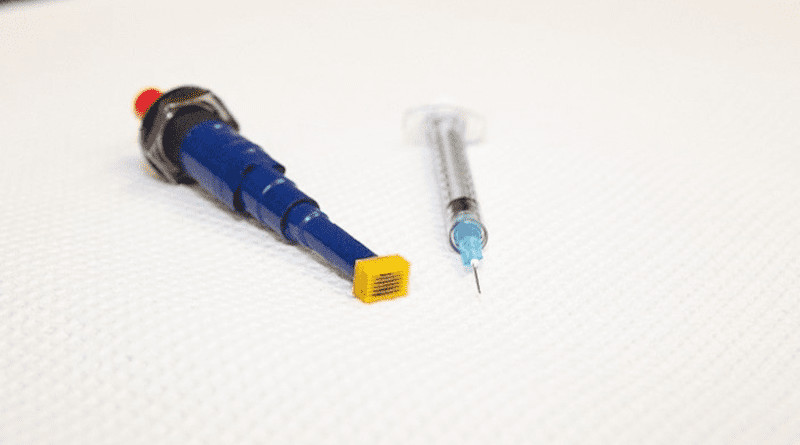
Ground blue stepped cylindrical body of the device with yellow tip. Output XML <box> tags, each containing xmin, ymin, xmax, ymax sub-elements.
<box><xmin>180</xmin><ymin>120</ymin><xmax>375</xmax><ymax>278</ymax></box>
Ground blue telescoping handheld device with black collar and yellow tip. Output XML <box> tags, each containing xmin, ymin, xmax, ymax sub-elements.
<box><xmin>134</xmin><ymin>87</ymin><xmax>409</xmax><ymax>302</ymax></box>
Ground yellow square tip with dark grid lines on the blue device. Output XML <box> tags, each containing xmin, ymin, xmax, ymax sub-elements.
<box><xmin>353</xmin><ymin>255</ymin><xmax>411</xmax><ymax>303</ymax></box>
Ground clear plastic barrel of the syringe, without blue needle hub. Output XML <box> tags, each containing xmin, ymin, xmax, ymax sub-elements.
<box><xmin>423</xmin><ymin>110</ymin><xmax>488</xmax><ymax>251</ymax></box>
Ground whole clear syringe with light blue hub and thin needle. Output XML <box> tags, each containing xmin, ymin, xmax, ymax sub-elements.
<box><xmin>406</xmin><ymin>105</ymin><xmax>488</xmax><ymax>293</ymax></box>
